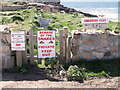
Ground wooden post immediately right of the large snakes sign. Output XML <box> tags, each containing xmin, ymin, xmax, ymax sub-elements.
<box><xmin>59</xmin><ymin>30</ymin><xmax>64</xmax><ymax>63</ymax></box>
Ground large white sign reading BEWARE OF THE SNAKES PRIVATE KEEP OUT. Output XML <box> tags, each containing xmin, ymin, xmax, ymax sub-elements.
<box><xmin>37</xmin><ymin>31</ymin><xmax>56</xmax><ymax>58</ymax></box>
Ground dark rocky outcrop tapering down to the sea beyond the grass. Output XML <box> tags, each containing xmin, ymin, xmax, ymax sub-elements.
<box><xmin>28</xmin><ymin>2</ymin><xmax>97</xmax><ymax>17</ymax></box>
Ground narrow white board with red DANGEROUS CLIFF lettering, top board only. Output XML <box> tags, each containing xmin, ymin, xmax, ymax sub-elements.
<box><xmin>81</xmin><ymin>18</ymin><xmax>109</xmax><ymax>24</ymax></box>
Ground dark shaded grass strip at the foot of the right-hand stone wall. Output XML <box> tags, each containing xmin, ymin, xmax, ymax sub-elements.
<box><xmin>64</xmin><ymin>58</ymin><xmax>120</xmax><ymax>77</ymax></box>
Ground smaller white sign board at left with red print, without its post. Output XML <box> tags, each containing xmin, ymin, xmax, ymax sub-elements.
<box><xmin>11</xmin><ymin>31</ymin><xmax>25</xmax><ymax>51</ymax></box>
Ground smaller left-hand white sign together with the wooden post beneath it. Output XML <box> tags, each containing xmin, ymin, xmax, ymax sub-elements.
<box><xmin>11</xmin><ymin>31</ymin><xmax>26</xmax><ymax>66</ymax></box>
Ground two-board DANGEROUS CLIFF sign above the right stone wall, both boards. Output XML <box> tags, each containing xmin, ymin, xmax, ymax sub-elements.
<box><xmin>81</xmin><ymin>18</ymin><xmax>109</xmax><ymax>29</ymax></box>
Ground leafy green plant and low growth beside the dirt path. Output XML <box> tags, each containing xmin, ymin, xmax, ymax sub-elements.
<box><xmin>67</xmin><ymin>65</ymin><xmax>108</xmax><ymax>80</ymax></box>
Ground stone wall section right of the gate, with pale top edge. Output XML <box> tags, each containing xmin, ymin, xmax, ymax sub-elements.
<box><xmin>72</xmin><ymin>31</ymin><xmax>120</xmax><ymax>60</ymax></box>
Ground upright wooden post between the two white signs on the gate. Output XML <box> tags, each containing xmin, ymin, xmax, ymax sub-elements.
<box><xmin>29</xmin><ymin>30</ymin><xmax>34</xmax><ymax>64</ymax></box>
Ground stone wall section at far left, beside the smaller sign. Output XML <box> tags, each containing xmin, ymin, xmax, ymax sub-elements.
<box><xmin>0</xmin><ymin>33</ymin><xmax>15</xmax><ymax>69</ymax></box>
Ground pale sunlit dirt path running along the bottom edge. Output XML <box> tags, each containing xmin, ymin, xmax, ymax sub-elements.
<box><xmin>0</xmin><ymin>78</ymin><xmax>118</xmax><ymax>88</ymax></box>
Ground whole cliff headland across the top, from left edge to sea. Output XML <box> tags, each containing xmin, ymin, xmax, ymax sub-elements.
<box><xmin>2</xmin><ymin>0</ymin><xmax>97</xmax><ymax>17</ymax></box>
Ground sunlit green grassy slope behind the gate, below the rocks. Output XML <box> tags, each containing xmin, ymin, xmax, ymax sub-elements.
<box><xmin>2</xmin><ymin>7</ymin><xmax>83</xmax><ymax>32</ymax></box>
